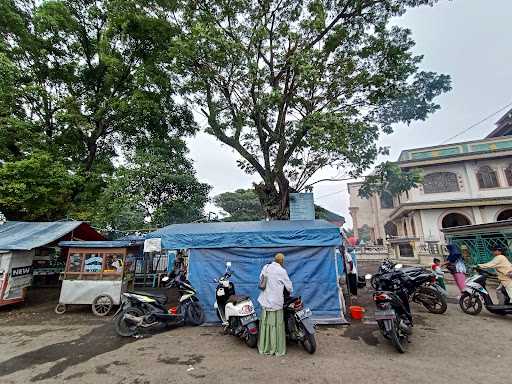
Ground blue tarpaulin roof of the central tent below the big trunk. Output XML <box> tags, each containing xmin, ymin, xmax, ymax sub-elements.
<box><xmin>147</xmin><ymin>220</ymin><xmax>340</xmax><ymax>249</ymax></box>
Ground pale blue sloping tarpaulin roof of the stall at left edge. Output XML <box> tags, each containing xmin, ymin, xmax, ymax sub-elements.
<box><xmin>0</xmin><ymin>221</ymin><xmax>83</xmax><ymax>251</ymax></box>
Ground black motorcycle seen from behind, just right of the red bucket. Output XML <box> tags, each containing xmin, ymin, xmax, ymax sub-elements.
<box><xmin>366</xmin><ymin>265</ymin><xmax>414</xmax><ymax>353</ymax></box>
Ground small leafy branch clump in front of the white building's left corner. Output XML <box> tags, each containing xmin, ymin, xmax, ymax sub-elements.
<box><xmin>359</xmin><ymin>162</ymin><xmax>423</xmax><ymax>199</ymax></box>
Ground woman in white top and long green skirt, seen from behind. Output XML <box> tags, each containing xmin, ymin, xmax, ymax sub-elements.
<box><xmin>258</xmin><ymin>253</ymin><xmax>293</xmax><ymax>356</ymax></box>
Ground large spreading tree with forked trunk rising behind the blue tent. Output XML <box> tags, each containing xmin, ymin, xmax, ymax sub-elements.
<box><xmin>171</xmin><ymin>0</ymin><xmax>450</xmax><ymax>218</ymax></box>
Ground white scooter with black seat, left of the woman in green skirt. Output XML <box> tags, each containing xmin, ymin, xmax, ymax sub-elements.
<box><xmin>214</xmin><ymin>261</ymin><xmax>258</xmax><ymax>348</ymax></box>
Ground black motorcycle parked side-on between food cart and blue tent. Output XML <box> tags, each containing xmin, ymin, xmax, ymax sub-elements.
<box><xmin>113</xmin><ymin>274</ymin><xmax>205</xmax><ymax>337</ymax></box>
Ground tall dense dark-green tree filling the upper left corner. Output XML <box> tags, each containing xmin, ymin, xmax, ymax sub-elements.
<box><xmin>0</xmin><ymin>0</ymin><xmax>208</xmax><ymax>222</ymax></box>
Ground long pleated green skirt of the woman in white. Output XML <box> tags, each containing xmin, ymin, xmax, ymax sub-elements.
<box><xmin>258</xmin><ymin>309</ymin><xmax>286</xmax><ymax>356</ymax></box>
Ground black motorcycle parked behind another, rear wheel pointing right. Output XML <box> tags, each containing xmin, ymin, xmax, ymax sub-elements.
<box><xmin>371</xmin><ymin>259</ymin><xmax>448</xmax><ymax>314</ymax></box>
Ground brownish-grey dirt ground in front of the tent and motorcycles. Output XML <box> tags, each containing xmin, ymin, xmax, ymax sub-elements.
<box><xmin>0</xmin><ymin>268</ymin><xmax>512</xmax><ymax>384</ymax></box>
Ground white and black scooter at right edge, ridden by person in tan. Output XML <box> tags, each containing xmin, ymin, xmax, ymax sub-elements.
<box><xmin>459</xmin><ymin>267</ymin><xmax>512</xmax><ymax>316</ymax></box>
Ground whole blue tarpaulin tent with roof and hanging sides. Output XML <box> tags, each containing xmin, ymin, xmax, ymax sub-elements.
<box><xmin>147</xmin><ymin>220</ymin><xmax>345</xmax><ymax>323</ymax></box>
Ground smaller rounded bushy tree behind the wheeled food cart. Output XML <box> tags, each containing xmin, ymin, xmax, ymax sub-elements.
<box><xmin>93</xmin><ymin>143</ymin><xmax>210</xmax><ymax>229</ymax></box>
